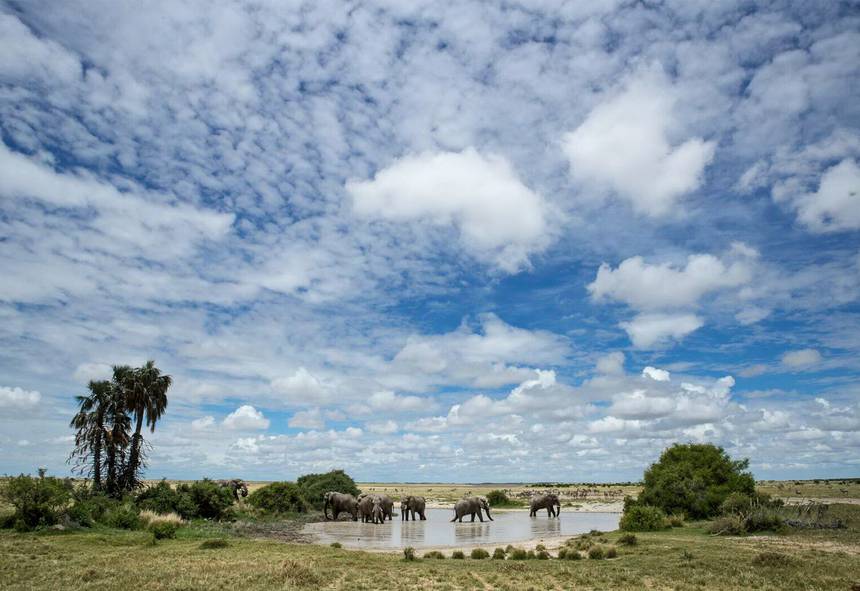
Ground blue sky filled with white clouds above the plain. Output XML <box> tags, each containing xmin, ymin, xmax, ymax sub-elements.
<box><xmin>0</xmin><ymin>0</ymin><xmax>860</xmax><ymax>482</ymax></box>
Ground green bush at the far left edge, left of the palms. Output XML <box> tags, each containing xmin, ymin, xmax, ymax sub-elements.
<box><xmin>0</xmin><ymin>474</ymin><xmax>72</xmax><ymax>531</ymax></box>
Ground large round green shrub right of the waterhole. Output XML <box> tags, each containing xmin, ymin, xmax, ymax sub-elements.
<box><xmin>638</xmin><ymin>443</ymin><xmax>755</xmax><ymax>518</ymax></box>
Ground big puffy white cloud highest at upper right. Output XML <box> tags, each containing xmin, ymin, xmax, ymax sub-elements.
<box><xmin>563</xmin><ymin>67</ymin><xmax>716</xmax><ymax>216</ymax></box>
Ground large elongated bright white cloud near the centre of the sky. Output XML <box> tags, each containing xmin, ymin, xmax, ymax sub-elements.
<box><xmin>346</xmin><ymin>148</ymin><xmax>549</xmax><ymax>272</ymax></box>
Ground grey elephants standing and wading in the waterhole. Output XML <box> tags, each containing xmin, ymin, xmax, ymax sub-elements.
<box><xmin>323</xmin><ymin>491</ymin><xmax>561</xmax><ymax>524</ymax></box>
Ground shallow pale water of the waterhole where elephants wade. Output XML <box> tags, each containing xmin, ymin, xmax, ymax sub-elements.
<box><xmin>304</xmin><ymin>509</ymin><xmax>621</xmax><ymax>548</ymax></box>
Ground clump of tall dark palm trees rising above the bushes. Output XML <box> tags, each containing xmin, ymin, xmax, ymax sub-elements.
<box><xmin>69</xmin><ymin>361</ymin><xmax>172</xmax><ymax>497</ymax></box>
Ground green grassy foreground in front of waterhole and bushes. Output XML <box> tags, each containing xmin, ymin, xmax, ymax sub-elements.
<box><xmin>0</xmin><ymin>505</ymin><xmax>860</xmax><ymax>591</ymax></box>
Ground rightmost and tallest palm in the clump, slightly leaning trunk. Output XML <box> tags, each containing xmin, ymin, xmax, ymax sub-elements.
<box><xmin>120</xmin><ymin>361</ymin><xmax>173</xmax><ymax>490</ymax></box>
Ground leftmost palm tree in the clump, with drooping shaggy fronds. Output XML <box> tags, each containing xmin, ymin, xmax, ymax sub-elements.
<box><xmin>69</xmin><ymin>380</ymin><xmax>111</xmax><ymax>489</ymax></box>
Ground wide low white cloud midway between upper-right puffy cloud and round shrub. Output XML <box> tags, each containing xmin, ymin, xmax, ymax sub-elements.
<box><xmin>588</xmin><ymin>254</ymin><xmax>752</xmax><ymax>310</ymax></box>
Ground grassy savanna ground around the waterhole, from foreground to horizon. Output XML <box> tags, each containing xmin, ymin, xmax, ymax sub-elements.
<box><xmin>0</xmin><ymin>480</ymin><xmax>860</xmax><ymax>591</ymax></box>
